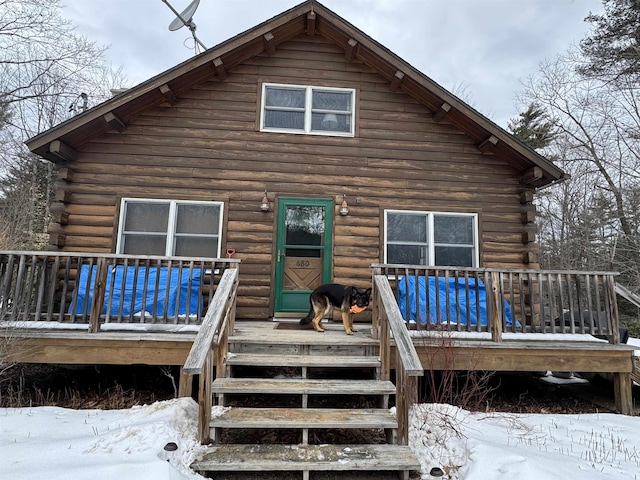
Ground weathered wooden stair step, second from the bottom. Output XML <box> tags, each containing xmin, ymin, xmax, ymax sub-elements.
<box><xmin>211</xmin><ymin>407</ymin><xmax>398</xmax><ymax>429</ymax></box>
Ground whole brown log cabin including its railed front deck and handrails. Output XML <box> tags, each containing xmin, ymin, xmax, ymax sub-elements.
<box><xmin>1</xmin><ymin>0</ymin><xmax>633</xmax><ymax>476</ymax></box>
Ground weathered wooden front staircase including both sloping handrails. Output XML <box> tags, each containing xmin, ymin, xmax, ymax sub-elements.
<box><xmin>182</xmin><ymin>268</ymin><xmax>424</xmax><ymax>480</ymax></box>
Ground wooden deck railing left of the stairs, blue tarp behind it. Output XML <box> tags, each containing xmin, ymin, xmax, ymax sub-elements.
<box><xmin>0</xmin><ymin>251</ymin><xmax>239</xmax><ymax>332</ymax></box>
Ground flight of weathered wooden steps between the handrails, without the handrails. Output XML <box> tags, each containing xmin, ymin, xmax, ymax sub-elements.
<box><xmin>192</xmin><ymin>323</ymin><xmax>420</xmax><ymax>480</ymax></box>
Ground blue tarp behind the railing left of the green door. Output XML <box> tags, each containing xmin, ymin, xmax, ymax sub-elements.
<box><xmin>69</xmin><ymin>265</ymin><xmax>202</xmax><ymax>316</ymax></box>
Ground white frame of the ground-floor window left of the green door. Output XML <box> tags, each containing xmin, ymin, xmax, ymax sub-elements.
<box><xmin>116</xmin><ymin>198</ymin><xmax>224</xmax><ymax>258</ymax></box>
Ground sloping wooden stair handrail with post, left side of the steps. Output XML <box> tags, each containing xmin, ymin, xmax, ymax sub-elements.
<box><xmin>182</xmin><ymin>268</ymin><xmax>238</xmax><ymax>444</ymax></box>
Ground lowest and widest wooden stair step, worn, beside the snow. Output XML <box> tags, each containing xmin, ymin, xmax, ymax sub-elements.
<box><xmin>191</xmin><ymin>444</ymin><xmax>420</xmax><ymax>472</ymax></box>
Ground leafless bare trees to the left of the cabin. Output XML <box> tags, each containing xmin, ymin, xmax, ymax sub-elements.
<box><xmin>0</xmin><ymin>0</ymin><xmax>126</xmax><ymax>249</ymax></box>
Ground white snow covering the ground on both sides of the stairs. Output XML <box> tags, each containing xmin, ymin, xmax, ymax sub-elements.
<box><xmin>0</xmin><ymin>398</ymin><xmax>640</xmax><ymax>480</ymax></box>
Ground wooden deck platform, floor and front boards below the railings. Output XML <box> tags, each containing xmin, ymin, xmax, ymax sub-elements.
<box><xmin>6</xmin><ymin>320</ymin><xmax>634</xmax><ymax>386</ymax></box>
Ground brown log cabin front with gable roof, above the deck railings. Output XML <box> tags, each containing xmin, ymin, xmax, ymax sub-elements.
<box><xmin>27</xmin><ymin>2</ymin><xmax>563</xmax><ymax>319</ymax></box>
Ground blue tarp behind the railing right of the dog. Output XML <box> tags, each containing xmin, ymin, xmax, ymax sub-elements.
<box><xmin>398</xmin><ymin>277</ymin><xmax>512</xmax><ymax>325</ymax></box>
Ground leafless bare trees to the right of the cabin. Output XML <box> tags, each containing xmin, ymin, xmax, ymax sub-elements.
<box><xmin>521</xmin><ymin>50</ymin><xmax>640</xmax><ymax>289</ymax></box>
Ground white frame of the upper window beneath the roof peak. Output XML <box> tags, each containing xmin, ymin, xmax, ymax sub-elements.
<box><xmin>260</xmin><ymin>83</ymin><xmax>356</xmax><ymax>137</ymax></box>
